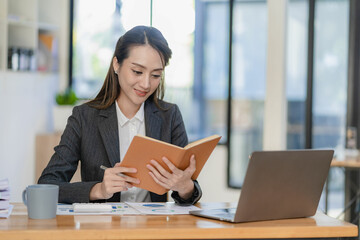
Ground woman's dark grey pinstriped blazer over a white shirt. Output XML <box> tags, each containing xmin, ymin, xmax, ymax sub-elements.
<box><xmin>38</xmin><ymin>100</ymin><xmax>201</xmax><ymax>204</ymax></box>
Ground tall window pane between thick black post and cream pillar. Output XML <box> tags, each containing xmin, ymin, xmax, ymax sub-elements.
<box><xmin>229</xmin><ymin>1</ymin><xmax>267</xmax><ymax>188</ymax></box>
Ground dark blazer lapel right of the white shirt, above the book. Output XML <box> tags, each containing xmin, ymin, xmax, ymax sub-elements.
<box><xmin>145</xmin><ymin>100</ymin><xmax>163</xmax><ymax>140</ymax></box>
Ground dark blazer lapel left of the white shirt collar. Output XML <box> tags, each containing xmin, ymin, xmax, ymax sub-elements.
<box><xmin>99</xmin><ymin>104</ymin><xmax>120</xmax><ymax>166</ymax></box>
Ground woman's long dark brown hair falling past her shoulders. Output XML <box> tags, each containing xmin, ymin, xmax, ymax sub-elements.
<box><xmin>88</xmin><ymin>26</ymin><xmax>172</xmax><ymax>109</ymax></box>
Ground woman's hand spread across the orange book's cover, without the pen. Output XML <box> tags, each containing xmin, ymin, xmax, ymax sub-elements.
<box><xmin>146</xmin><ymin>155</ymin><xmax>196</xmax><ymax>199</ymax></box>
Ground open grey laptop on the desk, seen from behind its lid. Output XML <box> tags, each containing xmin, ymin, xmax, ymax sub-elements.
<box><xmin>190</xmin><ymin>149</ymin><xmax>334</xmax><ymax>223</ymax></box>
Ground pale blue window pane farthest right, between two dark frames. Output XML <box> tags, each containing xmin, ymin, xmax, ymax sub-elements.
<box><xmin>312</xmin><ymin>0</ymin><xmax>349</xmax><ymax>217</ymax></box>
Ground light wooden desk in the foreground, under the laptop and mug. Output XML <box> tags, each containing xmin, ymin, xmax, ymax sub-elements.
<box><xmin>0</xmin><ymin>203</ymin><xmax>358</xmax><ymax>240</ymax></box>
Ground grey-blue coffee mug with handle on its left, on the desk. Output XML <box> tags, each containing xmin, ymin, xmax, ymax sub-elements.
<box><xmin>22</xmin><ymin>184</ymin><xmax>59</xmax><ymax>219</ymax></box>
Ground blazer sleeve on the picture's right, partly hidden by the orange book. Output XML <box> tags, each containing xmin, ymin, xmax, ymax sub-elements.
<box><xmin>171</xmin><ymin>105</ymin><xmax>202</xmax><ymax>205</ymax></box>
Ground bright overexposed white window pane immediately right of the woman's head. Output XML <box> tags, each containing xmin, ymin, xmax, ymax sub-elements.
<box><xmin>152</xmin><ymin>0</ymin><xmax>202</xmax><ymax>141</ymax></box>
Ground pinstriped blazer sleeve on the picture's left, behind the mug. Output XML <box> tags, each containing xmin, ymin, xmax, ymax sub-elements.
<box><xmin>38</xmin><ymin>107</ymin><xmax>98</xmax><ymax>203</ymax></box>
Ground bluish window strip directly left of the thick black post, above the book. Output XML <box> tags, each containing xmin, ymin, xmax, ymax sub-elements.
<box><xmin>194</xmin><ymin>1</ymin><xmax>229</xmax><ymax>143</ymax></box>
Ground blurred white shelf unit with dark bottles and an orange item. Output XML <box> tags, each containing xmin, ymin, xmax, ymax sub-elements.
<box><xmin>0</xmin><ymin>0</ymin><xmax>64</xmax><ymax>73</ymax></box>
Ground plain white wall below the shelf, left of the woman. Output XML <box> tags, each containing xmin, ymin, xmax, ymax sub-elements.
<box><xmin>0</xmin><ymin>72</ymin><xmax>58</xmax><ymax>202</ymax></box>
